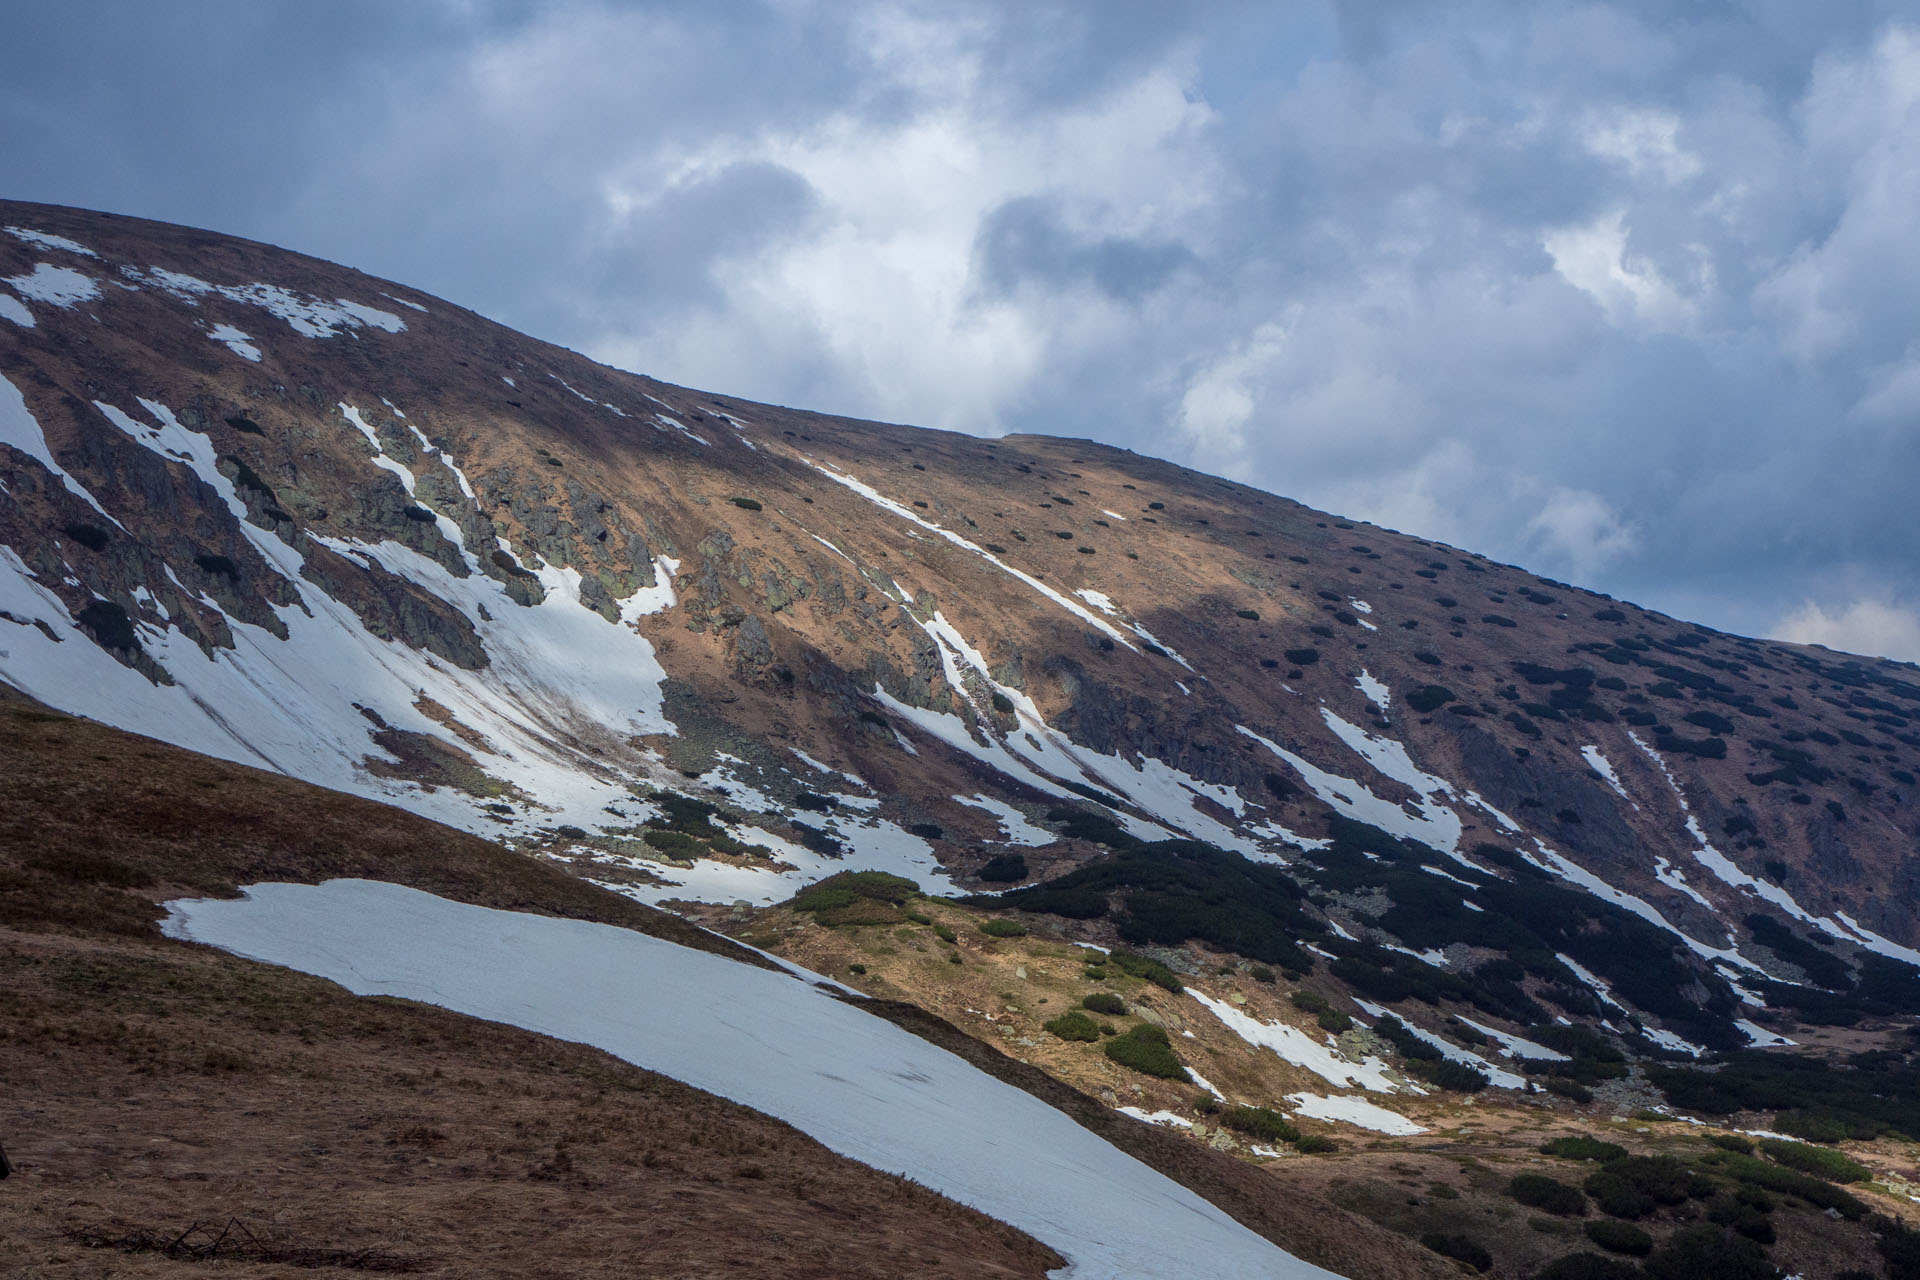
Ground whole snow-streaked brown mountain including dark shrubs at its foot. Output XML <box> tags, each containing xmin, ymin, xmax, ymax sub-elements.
<box><xmin>11</xmin><ymin>195</ymin><xmax>1920</xmax><ymax>1274</ymax></box>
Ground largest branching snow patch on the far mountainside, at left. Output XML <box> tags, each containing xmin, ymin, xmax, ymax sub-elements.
<box><xmin>0</xmin><ymin>401</ymin><xmax>691</xmax><ymax>833</ymax></box>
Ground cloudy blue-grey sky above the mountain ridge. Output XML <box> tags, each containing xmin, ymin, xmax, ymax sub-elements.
<box><xmin>11</xmin><ymin>0</ymin><xmax>1920</xmax><ymax>660</ymax></box>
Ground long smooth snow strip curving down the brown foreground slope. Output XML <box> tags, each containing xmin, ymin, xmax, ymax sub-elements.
<box><xmin>165</xmin><ymin>881</ymin><xmax>1331</xmax><ymax>1280</ymax></box>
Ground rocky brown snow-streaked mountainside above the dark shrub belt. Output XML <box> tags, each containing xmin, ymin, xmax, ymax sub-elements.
<box><xmin>0</xmin><ymin>203</ymin><xmax>1920</xmax><ymax>1051</ymax></box>
